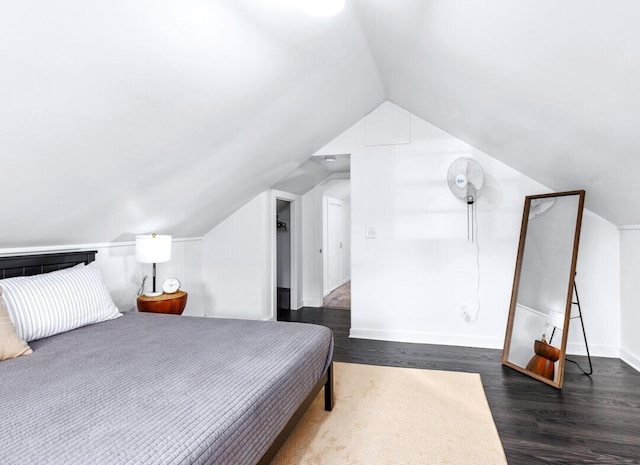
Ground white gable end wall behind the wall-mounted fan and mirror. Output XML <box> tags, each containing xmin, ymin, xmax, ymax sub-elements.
<box><xmin>318</xmin><ymin>102</ymin><xmax>620</xmax><ymax>356</ymax></box>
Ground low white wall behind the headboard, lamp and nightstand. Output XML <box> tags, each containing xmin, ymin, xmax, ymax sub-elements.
<box><xmin>0</xmin><ymin>238</ymin><xmax>203</xmax><ymax>316</ymax></box>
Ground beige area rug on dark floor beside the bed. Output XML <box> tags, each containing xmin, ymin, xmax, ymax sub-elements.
<box><xmin>272</xmin><ymin>362</ymin><xmax>507</xmax><ymax>465</ymax></box>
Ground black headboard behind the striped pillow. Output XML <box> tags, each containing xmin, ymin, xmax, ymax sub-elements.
<box><xmin>0</xmin><ymin>250</ymin><xmax>98</xmax><ymax>279</ymax></box>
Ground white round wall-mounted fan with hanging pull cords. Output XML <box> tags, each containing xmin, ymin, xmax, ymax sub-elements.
<box><xmin>447</xmin><ymin>157</ymin><xmax>484</xmax><ymax>241</ymax></box>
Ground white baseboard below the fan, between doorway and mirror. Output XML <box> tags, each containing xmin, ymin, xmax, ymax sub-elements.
<box><xmin>349</xmin><ymin>328</ymin><xmax>504</xmax><ymax>349</ymax></box>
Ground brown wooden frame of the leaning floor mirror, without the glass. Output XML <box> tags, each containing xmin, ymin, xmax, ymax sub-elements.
<box><xmin>502</xmin><ymin>190</ymin><xmax>585</xmax><ymax>389</ymax></box>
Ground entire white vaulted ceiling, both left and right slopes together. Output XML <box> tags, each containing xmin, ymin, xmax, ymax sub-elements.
<box><xmin>0</xmin><ymin>0</ymin><xmax>640</xmax><ymax>248</ymax></box>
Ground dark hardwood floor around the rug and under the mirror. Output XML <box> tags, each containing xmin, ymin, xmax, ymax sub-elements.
<box><xmin>278</xmin><ymin>307</ymin><xmax>640</xmax><ymax>465</ymax></box>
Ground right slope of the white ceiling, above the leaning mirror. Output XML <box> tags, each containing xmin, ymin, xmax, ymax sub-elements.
<box><xmin>358</xmin><ymin>0</ymin><xmax>640</xmax><ymax>225</ymax></box>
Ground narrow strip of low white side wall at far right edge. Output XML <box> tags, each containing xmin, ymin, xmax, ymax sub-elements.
<box><xmin>620</xmin><ymin>226</ymin><xmax>640</xmax><ymax>370</ymax></box>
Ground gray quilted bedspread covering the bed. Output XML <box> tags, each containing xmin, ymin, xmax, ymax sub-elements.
<box><xmin>0</xmin><ymin>313</ymin><xmax>333</xmax><ymax>465</ymax></box>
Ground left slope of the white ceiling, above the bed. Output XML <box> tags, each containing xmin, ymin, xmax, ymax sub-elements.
<box><xmin>0</xmin><ymin>0</ymin><xmax>385</xmax><ymax>247</ymax></box>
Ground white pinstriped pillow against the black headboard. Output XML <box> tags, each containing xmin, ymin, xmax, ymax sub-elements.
<box><xmin>0</xmin><ymin>262</ymin><xmax>122</xmax><ymax>342</ymax></box>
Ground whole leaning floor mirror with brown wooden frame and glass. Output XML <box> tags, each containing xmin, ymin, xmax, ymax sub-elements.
<box><xmin>502</xmin><ymin>190</ymin><xmax>585</xmax><ymax>389</ymax></box>
